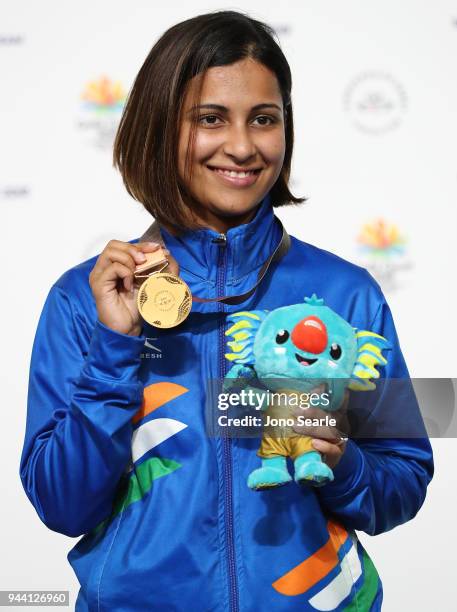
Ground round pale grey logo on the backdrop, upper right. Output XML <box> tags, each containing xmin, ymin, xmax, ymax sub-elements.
<box><xmin>343</xmin><ymin>72</ymin><xmax>408</xmax><ymax>134</ymax></box>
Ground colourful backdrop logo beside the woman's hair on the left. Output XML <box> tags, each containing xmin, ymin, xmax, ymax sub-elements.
<box><xmin>77</xmin><ymin>76</ymin><xmax>126</xmax><ymax>150</ymax></box>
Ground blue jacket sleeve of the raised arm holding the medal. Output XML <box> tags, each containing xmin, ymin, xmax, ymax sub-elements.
<box><xmin>20</xmin><ymin>285</ymin><xmax>144</xmax><ymax>537</ymax></box>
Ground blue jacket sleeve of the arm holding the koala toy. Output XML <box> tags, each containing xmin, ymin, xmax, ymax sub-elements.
<box><xmin>317</xmin><ymin>300</ymin><xmax>434</xmax><ymax>535</ymax></box>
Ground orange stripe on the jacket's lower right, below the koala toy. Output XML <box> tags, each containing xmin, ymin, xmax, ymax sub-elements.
<box><xmin>272</xmin><ymin>521</ymin><xmax>348</xmax><ymax>595</ymax></box>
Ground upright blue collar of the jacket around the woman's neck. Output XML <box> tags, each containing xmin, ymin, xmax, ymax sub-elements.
<box><xmin>140</xmin><ymin>193</ymin><xmax>281</xmax><ymax>285</ymax></box>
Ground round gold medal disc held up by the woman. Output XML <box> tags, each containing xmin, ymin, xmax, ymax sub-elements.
<box><xmin>137</xmin><ymin>272</ymin><xmax>192</xmax><ymax>328</ymax></box>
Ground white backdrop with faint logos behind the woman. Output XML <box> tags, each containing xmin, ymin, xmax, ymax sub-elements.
<box><xmin>0</xmin><ymin>0</ymin><xmax>457</xmax><ymax>612</ymax></box>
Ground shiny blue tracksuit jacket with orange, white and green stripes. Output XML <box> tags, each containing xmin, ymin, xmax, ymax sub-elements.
<box><xmin>20</xmin><ymin>195</ymin><xmax>433</xmax><ymax>612</ymax></box>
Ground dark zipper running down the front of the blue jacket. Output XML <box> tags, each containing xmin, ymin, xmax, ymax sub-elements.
<box><xmin>215</xmin><ymin>234</ymin><xmax>239</xmax><ymax>612</ymax></box>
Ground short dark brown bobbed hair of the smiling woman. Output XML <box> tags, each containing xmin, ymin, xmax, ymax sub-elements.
<box><xmin>113</xmin><ymin>11</ymin><xmax>305</xmax><ymax>233</ymax></box>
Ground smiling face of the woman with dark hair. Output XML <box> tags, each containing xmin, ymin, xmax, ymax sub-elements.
<box><xmin>179</xmin><ymin>59</ymin><xmax>286</xmax><ymax>232</ymax></box>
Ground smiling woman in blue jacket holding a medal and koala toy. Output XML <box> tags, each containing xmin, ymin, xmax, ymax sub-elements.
<box><xmin>20</xmin><ymin>11</ymin><xmax>433</xmax><ymax>612</ymax></box>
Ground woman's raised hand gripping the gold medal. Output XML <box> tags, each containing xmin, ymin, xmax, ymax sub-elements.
<box><xmin>89</xmin><ymin>240</ymin><xmax>179</xmax><ymax>336</ymax></box>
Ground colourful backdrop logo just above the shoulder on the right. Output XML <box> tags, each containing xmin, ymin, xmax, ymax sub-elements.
<box><xmin>357</xmin><ymin>218</ymin><xmax>413</xmax><ymax>291</ymax></box>
